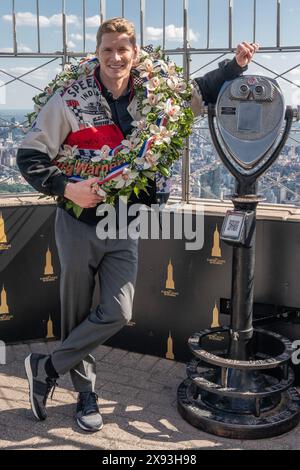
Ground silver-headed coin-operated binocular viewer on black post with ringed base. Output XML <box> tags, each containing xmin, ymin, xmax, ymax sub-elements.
<box><xmin>178</xmin><ymin>76</ymin><xmax>300</xmax><ymax>439</ymax></box>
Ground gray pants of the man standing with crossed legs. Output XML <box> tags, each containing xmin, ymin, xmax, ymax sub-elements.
<box><xmin>52</xmin><ymin>208</ymin><xmax>138</xmax><ymax>392</ymax></box>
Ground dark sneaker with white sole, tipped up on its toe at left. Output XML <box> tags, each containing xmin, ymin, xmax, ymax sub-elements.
<box><xmin>25</xmin><ymin>354</ymin><xmax>56</xmax><ymax>421</ymax></box>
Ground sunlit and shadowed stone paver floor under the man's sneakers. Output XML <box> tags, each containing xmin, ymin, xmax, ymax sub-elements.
<box><xmin>0</xmin><ymin>342</ymin><xmax>300</xmax><ymax>450</ymax></box>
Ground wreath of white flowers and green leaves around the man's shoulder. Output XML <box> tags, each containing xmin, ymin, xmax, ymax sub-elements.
<box><xmin>28</xmin><ymin>46</ymin><xmax>194</xmax><ymax>217</ymax></box>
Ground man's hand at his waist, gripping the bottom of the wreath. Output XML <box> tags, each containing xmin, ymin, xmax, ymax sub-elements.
<box><xmin>64</xmin><ymin>178</ymin><xmax>106</xmax><ymax>209</ymax></box>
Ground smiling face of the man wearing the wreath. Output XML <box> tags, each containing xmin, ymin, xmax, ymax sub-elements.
<box><xmin>97</xmin><ymin>33</ymin><xmax>137</xmax><ymax>81</ymax></box>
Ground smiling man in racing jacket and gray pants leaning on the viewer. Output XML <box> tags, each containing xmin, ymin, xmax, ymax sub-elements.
<box><xmin>17</xmin><ymin>18</ymin><xmax>258</xmax><ymax>431</ymax></box>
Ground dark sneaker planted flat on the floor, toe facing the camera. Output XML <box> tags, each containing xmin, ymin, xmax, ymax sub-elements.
<box><xmin>76</xmin><ymin>392</ymin><xmax>103</xmax><ymax>432</ymax></box>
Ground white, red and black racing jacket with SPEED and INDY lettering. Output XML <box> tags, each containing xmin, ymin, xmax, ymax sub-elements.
<box><xmin>17</xmin><ymin>59</ymin><xmax>246</xmax><ymax>224</ymax></box>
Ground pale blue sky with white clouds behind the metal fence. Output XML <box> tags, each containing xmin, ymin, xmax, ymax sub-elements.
<box><xmin>0</xmin><ymin>0</ymin><xmax>300</xmax><ymax>111</ymax></box>
